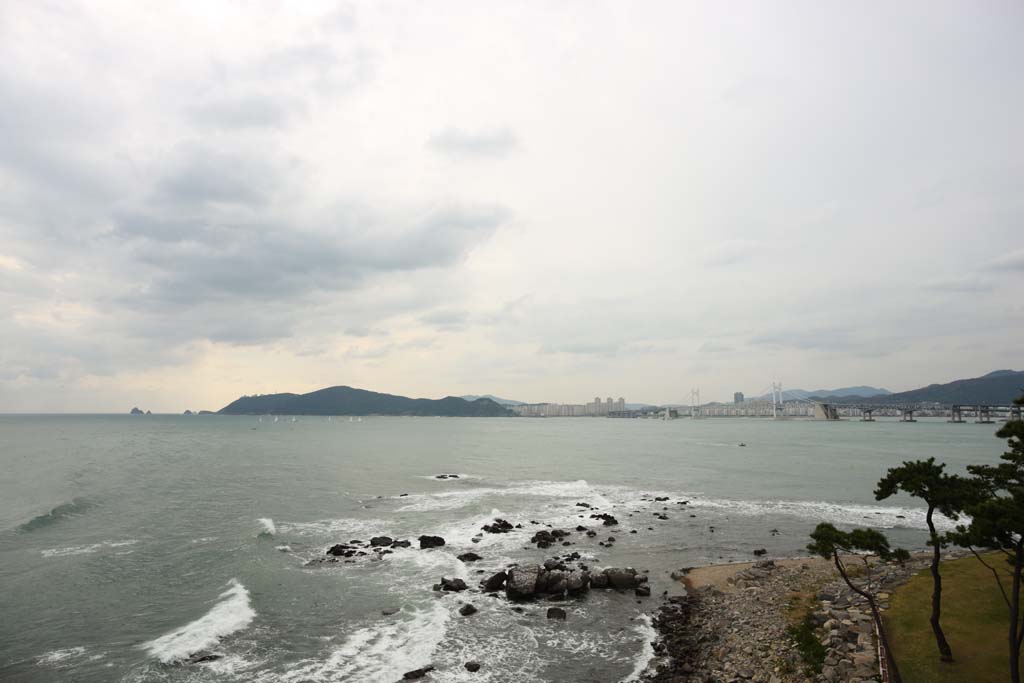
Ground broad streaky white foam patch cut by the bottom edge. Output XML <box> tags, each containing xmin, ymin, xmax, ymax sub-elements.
<box><xmin>275</xmin><ymin>601</ymin><xmax>450</xmax><ymax>683</ymax></box>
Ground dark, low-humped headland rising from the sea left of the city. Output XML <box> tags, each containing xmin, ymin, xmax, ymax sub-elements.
<box><xmin>218</xmin><ymin>386</ymin><xmax>511</xmax><ymax>418</ymax></box>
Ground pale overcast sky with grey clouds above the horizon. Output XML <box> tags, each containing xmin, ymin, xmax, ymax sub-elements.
<box><xmin>0</xmin><ymin>0</ymin><xmax>1024</xmax><ymax>413</ymax></box>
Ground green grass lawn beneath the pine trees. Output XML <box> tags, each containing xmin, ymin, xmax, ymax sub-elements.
<box><xmin>884</xmin><ymin>555</ymin><xmax>1010</xmax><ymax>683</ymax></box>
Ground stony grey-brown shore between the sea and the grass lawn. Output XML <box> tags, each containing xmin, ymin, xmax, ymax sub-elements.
<box><xmin>643</xmin><ymin>555</ymin><xmax>946</xmax><ymax>683</ymax></box>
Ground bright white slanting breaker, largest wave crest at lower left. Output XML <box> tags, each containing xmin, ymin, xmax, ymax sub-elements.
<box><xmin>142</xmin><ymin>579</ymin><xmax>256</xmax><ymax>664</ymax></box>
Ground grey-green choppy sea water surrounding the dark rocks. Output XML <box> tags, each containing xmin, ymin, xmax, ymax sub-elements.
<box><xmin>0</xmin><ymin>416</ymin><xmax>1002</xmax><ymax>683</ymax></box>
